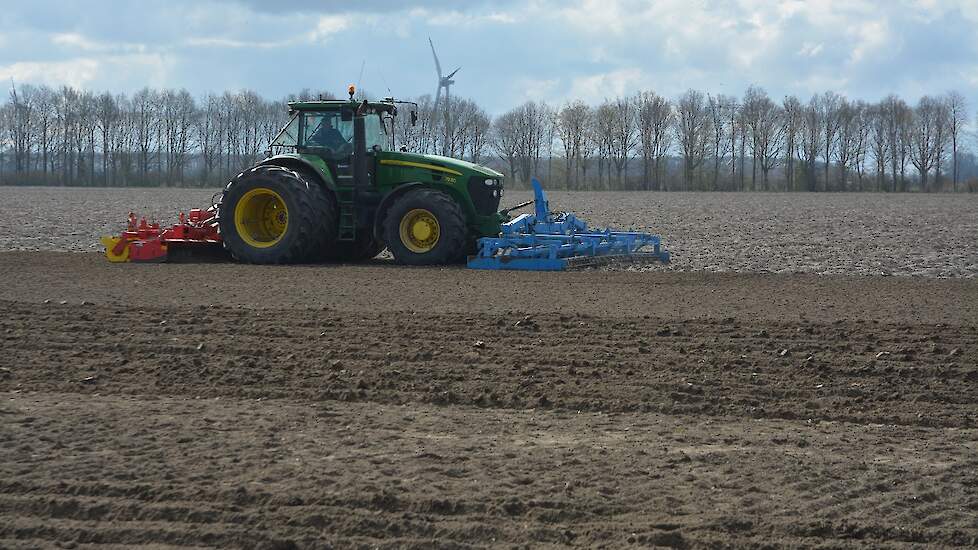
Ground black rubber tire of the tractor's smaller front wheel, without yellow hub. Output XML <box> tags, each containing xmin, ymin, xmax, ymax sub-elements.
<box><xmin>384</xmin><ymin>189</ymin><xmax>468</xmax><ymax>265</ymax></box>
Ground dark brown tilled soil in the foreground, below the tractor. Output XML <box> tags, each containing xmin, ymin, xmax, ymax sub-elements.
<box><xmin>0</xmin><ymin>252</ymin><xmax>978</xmax><ymax>548</ymax></box>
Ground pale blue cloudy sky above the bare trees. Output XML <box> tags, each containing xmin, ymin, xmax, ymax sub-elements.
<box><xmin>0</xmin><ymin>0</ymin><xmax>978</xmax><ymax>113</ymax></box>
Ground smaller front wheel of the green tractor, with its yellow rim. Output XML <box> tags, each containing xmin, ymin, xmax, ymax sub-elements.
<box><xmin>384</xmin><ymin>189</ymin><xmax>467</xmax><ymax>265</ymax></box>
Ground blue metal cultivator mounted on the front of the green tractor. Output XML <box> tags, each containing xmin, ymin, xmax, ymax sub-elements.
<box><xmin>468</xmin><ymin>178</ymin><xmax>669</xmax><ymax>271</ymax></box>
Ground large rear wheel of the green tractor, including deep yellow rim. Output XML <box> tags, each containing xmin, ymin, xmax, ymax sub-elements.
<box><xmin>219</xmin><ymin>166</ymin><xmax>336</xmax><ymax>264</ymax></box>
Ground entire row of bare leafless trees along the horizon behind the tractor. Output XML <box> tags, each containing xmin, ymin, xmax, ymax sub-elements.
<box><xmin>0</xmin><ymin>85</ymin><xmax>978</xmax><ymax>192</ymax></box>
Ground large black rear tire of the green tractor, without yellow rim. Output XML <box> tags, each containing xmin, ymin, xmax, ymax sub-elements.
<box><xmin>219</xmin><ymin>166</ymin><xmax>337</xmax><ymax>264</ymax></box>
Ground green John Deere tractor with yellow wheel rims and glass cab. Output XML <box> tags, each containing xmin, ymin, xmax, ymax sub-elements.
<box><xmin>218</xmin><ymin>87</ymin><xmax>505</xmax><ymax>265</ymax></box>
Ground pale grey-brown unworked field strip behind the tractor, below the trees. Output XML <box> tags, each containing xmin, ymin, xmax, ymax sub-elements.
<box><xmin>0</xmin><ymin>187</ymin><xmax>978</xmax><ymax>278</ymax></box>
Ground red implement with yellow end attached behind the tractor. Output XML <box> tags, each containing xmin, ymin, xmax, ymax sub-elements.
<box><xmin>102</xmin><ymin>206</ymin><xmax>223</xmax><ymax>262</ymax></box>
